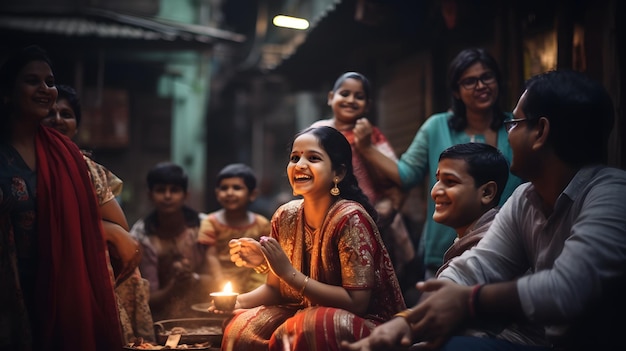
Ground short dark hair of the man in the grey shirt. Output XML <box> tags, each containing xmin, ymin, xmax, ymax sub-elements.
<box><xmin>521</xmin><ymin>70</ymin><xmax>615</xmax><ymax>167</ymax></box>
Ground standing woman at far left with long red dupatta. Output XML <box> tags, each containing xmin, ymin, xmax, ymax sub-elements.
<box><xmin>0</xmin><ymin>46</ymin><xmax>122</xmax><ymax>350</ymax></box>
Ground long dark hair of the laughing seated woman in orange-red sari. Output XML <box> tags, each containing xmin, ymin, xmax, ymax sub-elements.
<box><xmin>289</xmin><ymin>126</ymin><xmax>378</xmax><ymax>221</ymax></box>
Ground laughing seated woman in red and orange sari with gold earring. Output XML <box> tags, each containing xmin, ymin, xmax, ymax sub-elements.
<box><xmin>222</xmin><ymin>127</ymin><xmax>405</xmax><ymax>351</ymax></box>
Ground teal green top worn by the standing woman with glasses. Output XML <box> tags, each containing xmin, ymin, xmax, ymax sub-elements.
<box><xmin>398</xmin><ymin>112</ymin><xmax>522</xmax><ymax>270</ymax></box>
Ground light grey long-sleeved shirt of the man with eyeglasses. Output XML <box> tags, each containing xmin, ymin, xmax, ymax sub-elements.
<box><xmin>439</xmin><ymin>166</ymin><xmax>626</xmax><ymax>346</ymax></box>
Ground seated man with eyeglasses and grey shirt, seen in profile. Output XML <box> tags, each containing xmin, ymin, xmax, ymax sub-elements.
<box><xmin>345</xmin><ymin>71</ymin><xmax>626</xmax><ymax>351</ymax></box>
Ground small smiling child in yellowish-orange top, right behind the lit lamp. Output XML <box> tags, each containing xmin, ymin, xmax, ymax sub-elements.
<box><xmin>198</xmin><ymin>163</ymin><xmax>270</xmax><ymax>293</ymax></box>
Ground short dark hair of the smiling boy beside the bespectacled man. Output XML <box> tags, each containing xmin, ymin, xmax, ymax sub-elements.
<box><xmin>439</xmin><ymin>143</ymin><xmax>509</xmax><ymax>204</ymax></box>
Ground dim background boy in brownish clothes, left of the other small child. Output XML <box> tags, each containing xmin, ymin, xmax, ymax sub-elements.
<box><xmin>130</xmin><ymin>162</ymin><xmax>221</xmax><ymax>321</ymax></box>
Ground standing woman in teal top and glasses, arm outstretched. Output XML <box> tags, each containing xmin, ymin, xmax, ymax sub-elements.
<box><xmin>355</xmin><ymin>48</ymin><xmax>522</xmax><ymax>278</ymax></box>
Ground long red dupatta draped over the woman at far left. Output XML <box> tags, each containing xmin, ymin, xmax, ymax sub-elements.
<box><xmin>33</xmin><ymin>127</ymin><xmax>122</xmax><ymax>351</ymax></box>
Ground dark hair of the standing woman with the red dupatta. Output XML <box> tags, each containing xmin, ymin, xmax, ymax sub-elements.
<box><xmin>0</xmin><ymin>45</ymin><xmax>52</xmax><ymax>137</ymax></box>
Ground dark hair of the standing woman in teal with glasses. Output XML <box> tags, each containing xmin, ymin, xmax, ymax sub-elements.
<box><xmin>448</xmin><ymin>48</ymin><xmax>506</xmax><ymax>131</ymax></box>
